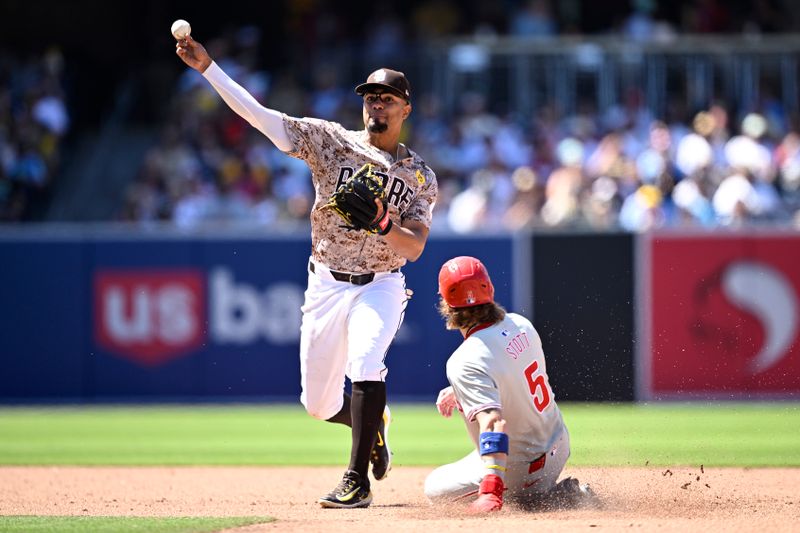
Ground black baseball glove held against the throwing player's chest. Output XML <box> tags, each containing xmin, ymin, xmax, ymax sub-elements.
<box><xmin>325</xmin><ymin>163</ymin><xmax>392</xmax><ymax>235</ymax></box>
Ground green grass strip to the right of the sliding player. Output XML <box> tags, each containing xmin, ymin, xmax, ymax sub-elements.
<box><xmin>564</xmin><ymin>403</ymin><xmax>800</xmax><ymax>466</ymax></box>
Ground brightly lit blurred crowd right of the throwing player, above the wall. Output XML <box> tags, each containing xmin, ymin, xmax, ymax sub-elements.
<box><xmin>418</xmin><ymin>94</ymin><xmax>800</xmax><ymax>232</ymax></box>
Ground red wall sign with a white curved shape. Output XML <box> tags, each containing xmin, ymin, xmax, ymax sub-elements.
<box><xmin>639</xmin><ymin>235</ymin><xmax>800</xmax><ymax>399</ymax></box>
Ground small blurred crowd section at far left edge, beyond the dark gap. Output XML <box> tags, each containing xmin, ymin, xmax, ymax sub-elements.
<box><xmin>0</xmin><ymin>48</ymin><xmax>70</xmax><ymax>221</ymax></box>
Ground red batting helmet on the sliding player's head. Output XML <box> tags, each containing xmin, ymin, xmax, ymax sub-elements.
<box><xmin>439</xmin><ymin>255</ymin><xmax>494</xmax><ymax>307</ymax></box>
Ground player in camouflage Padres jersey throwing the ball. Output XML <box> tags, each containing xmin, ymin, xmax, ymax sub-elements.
<box><xmin>176</xmin><ymin>36</ymin><xmax>437</xmax><ymax>508</ymax></box>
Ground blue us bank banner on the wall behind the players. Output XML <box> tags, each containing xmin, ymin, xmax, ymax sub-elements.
<box><xmin>0</xmin><ymin>231</ymin><xmax>512</xmax><ymax>402</ymax></box>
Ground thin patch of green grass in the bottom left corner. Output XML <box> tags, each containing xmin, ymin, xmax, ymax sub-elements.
<box><xmin>0</xmin><ymin>516</ymin><xmax>274</xmax><ymax>533</ymax></box>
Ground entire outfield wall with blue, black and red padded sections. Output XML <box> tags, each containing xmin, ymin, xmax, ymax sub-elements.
<box><xmin>0</xmin><ymin>229</ymin><xmax>800</xmax><ymax>403</ymax></box>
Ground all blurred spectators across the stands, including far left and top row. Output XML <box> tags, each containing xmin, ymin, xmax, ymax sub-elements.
<box><xmin>0</xmin><ymin>0</ymin><xmax>800</xmax><ymax>232</ymax></box>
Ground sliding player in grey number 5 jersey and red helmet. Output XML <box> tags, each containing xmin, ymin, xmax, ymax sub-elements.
<box><xmin>425</xmin><ymin>257</ymin><xmax>590</xmax><ymax>513</ymax></box>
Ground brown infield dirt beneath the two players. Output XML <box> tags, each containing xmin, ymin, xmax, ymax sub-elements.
<box><xmin>0</xmin><ymin>465</ymin><xmax>800</xmax><ymax>533</ymax></box>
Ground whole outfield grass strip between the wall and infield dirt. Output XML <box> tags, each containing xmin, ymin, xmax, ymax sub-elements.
<box><xmin>0</xmin><ymin>403</ymin><xmax>800</xmax><ymax>466</ymax></box>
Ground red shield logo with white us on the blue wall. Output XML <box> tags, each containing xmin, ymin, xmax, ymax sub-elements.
<box><xmin>94</xmin><ymin>269</ymin><xmax>206</xmax><ymax>366</ymax></box>
